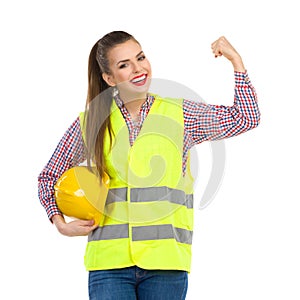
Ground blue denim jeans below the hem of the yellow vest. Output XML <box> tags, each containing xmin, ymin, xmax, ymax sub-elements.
<box><xmin>89</xmin><ymin>267</ymin><xmax>188</xmax><ymax>300</ymax></box>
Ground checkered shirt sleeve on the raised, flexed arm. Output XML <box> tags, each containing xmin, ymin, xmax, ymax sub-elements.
<box><xmin>183</xmin><ymin>72</ymin><xmax>260</xmax><ymax>146</ymax></box>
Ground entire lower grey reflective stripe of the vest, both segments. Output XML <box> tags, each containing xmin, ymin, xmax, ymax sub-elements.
<box><xmin>88</xmin><ymin>224</ymin><xmax>193</xmax><ymax>244</ymax></box>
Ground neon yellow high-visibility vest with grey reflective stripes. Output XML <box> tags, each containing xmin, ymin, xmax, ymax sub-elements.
<box><xmin>80</xmin><ymin>95</ymin><xmax>193</xmax><ymax>272</ymax></box>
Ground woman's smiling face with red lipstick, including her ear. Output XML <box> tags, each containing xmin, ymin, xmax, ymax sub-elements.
<box><xmin>103</xmin><ymin>40</ymin><xmax>152</xmax><ymax>100</ymax></box>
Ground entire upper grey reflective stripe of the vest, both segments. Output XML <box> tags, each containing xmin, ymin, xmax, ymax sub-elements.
<box><xmin>106</xmin><ymin>186</ymin><xmax>194</xmax><ymax>208</ymax></box>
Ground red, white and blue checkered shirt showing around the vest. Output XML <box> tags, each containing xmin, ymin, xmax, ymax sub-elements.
<box><xmin>38</xmin><ymin>72</ymin><xmax>260</xmax><ymax>219</ymax></box>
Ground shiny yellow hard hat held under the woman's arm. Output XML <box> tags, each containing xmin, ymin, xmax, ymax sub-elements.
<box><xmin>54</xmin><ymin>166</ymin><xmax>109</xmax><ymax>224</ymax></box>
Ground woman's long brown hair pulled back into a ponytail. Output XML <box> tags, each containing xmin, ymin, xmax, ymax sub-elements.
<box><xmin>84</xmin><ymin>31</ymin><xmax>138</xmax><ymax>178</ymax></box>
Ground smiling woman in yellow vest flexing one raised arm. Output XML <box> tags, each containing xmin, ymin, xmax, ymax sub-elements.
<box><xmin>39</xmin><ymin>31</ymin><xmax>260</xmax><ymax>300</ymax></box>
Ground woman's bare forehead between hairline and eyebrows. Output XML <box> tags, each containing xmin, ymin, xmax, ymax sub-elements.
<box><xmin>108</xmin><ymin>40</ymin><xmax>142</xmax><ymax>64</ymax></box>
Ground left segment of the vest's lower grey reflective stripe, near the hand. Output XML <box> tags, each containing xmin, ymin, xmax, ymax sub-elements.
<box><xmin>88</xmin><ymin>224</ymin><xmax>129</xmax><ymax>242</ymax></box>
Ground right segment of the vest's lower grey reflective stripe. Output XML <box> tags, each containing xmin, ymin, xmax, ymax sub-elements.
<box><xmin>132</xmin><ymin>224</ymin><xmax>193</xmax><ymax>244</ymax></box>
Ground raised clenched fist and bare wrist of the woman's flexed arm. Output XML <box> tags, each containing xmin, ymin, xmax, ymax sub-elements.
<box><xmin>211</xmin><ymin>36</ymin><xmax>246</xmax><ymax>72</ymax></box>
